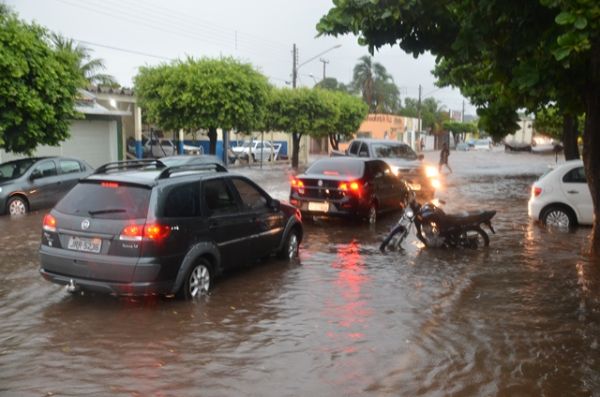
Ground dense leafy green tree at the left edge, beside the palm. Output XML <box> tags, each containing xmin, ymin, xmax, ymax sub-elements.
<box><xmin>0</xmin><ymin>4</ymin><xmax>81</xmax><ymax>155</ymax></box>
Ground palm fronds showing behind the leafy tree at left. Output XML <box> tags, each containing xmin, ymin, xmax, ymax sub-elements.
<box><xmin>51</xmin><ymin>33</ymin><xmax>119</xmax><ymax>87</ymax></box>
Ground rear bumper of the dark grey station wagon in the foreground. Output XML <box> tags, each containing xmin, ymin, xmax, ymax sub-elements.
<box><xmin>40</xmin><ymin>245</ymin><xmax>175</xmax><ymax>295</ymax></box>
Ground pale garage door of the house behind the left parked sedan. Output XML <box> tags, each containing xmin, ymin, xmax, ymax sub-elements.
<box><xmin>0</xmin><ymin>120</ymin><xmax>118</xmax><ymax>167</ymax></box>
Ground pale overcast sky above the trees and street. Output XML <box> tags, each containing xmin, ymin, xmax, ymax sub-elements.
<box><xmin>0</xmin><ymin>0</ymin><xmax>475</xmax><ymax>114</ymax></box>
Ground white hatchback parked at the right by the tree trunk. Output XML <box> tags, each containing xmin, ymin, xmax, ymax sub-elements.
<box><xmin>527</xmin><ymin>160</ymin><xmax>594</xmax><ymax>228</ymax></box>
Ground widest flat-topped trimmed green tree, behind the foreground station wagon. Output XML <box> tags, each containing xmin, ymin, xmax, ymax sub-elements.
<box><xmin>134</xmin><ymin>58</ymin><xmax>271</xmax><ymax>154</ymax></box>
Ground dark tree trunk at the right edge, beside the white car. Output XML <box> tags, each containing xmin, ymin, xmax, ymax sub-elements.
<box><xmin>583</xmin><ymin>41</ymin><xmax>600</xmax><ymax>257</ymax></box>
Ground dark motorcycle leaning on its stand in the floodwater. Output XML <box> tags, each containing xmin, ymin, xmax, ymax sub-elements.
<box><xmin>379</xmin><ymin>195</ymin><xmax>496</xmax><ymax>252</ymax></box>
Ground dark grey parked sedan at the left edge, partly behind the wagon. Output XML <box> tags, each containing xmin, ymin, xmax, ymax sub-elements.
<box><xmin>0</xmin><ymin>157</ymin><xmax>93</xmax><ymax>215</ymax></box>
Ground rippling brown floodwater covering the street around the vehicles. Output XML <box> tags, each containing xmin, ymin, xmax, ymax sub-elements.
<box><xmin>0</xmin><ymin>151</ymin><xmax>600</xmax><ymax>396</ymax></box>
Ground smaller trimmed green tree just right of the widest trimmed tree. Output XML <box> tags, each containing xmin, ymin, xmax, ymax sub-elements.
<box><xmin>269</xmin><ymin>88</ymin><xmax>338</xmax><ymax>168</ymax></box>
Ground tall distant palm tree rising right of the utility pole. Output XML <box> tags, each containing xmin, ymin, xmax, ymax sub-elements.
<box><xmin>352</xmin><ymin>55</ymin><xmax>400</xmax><ymax>113</ymax></box>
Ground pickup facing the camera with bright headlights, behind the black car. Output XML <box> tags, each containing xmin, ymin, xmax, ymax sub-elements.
<box><xmin>338</xmin><ymin>138</ymin><xmax>441</xmax><ymax>200</ymax></box>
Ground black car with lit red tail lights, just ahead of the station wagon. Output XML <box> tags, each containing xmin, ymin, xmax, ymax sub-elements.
<box><xmin>290</xmin><ymin>157</ymin><xmax>408</xmax><ymax>223</ymax></box>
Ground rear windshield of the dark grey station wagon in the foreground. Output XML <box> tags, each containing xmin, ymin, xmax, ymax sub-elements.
<box><xmin>55</xmin><ymin>182</ymin><xmax>152</xmax><ymax>219</ymax></box>
